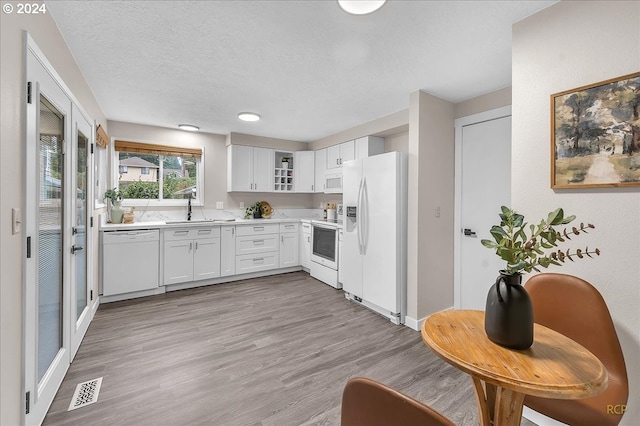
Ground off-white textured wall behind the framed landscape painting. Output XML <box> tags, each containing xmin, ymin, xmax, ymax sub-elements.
<box><xmin>511</xmin><ymin>1</ymin><xmax>640</xmax><ymax>425</ymax></box>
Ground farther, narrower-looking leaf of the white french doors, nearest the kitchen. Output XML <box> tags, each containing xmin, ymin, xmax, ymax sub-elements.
<box><xmin>70</xmin><ymin>105</ymin><xmax>93</xmax><ymax>359</ymax></box>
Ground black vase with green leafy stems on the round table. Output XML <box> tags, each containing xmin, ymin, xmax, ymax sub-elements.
<box><xmin>481</xmin><ymin>206</ymin><xmax>600</xmax><ymax>349</ymax></box>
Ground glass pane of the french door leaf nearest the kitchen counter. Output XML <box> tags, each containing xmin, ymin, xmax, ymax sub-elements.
<box><xmin>74</xmin><ymin>131</ymin><xmax>89</xmax><ymax>320</ymax></box>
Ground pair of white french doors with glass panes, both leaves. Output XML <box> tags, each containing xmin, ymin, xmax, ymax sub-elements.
<box><xmin>23</xmin><ymin>35</ymin><xmax>94</xmax><ymax>425</ymax></box>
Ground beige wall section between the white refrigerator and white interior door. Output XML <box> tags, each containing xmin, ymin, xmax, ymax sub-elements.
<box><xmin>407</xmin><ymin>91</ymin><xmax>454</xmax><ymax>321</ymax></box>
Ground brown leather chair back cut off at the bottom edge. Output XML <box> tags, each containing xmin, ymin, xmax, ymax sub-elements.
<box><xmin>340</xmin><ymin>377</ymin><xmax>453</xmax><ymax>426</ymax></box>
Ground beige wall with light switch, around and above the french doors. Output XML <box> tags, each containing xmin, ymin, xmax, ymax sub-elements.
<box><xmin>0</xmin><ymin>13</ymin><xmax>106</xmax><ymax>425</ymax></box>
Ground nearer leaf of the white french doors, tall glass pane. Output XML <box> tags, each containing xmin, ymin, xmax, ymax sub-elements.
<box><xmin>24</xmin><ymin>44</ymin><xmax>71</xmax><ymax>425</ymax></box>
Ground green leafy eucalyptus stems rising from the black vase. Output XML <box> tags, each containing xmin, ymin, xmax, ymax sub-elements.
<box><xmin>481</xmin><ymin>206</ymin><xmax>600</xmax><ymax>275</ymax></box>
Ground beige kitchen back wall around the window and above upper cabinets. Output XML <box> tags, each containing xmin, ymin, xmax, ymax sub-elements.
<box><xmin>109</xmin><ymin>121</ymin><xmax>317</xmax><ymax>212</ymax></box>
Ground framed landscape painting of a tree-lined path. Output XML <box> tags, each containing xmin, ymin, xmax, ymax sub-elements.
<box><xmin>551</xmin><ymin>72</ymin><xmax>640</xmax><ymax>189</ymax></box>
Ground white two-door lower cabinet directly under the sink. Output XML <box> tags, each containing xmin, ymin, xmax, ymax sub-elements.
<box><xmin>163</xmin><ymin>227</ymin><xmax>220</xmax><ymax>285</ymax></box>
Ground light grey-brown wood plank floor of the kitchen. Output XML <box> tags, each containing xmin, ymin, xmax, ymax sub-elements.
<box><xmin>44</xmin><ymin>272</ymin><xmax>532</xmax><ymax>426</ymax></box>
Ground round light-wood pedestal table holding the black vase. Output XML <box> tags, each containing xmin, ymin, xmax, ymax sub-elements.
<box><xmin>422</xmin><ymin>310</ymin><xmax>607</xmax><ymax>426</ymax></box>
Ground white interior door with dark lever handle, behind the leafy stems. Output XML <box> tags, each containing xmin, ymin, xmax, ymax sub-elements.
<box><xmin>454</xmin><ymin>107</ymin><xmax>511</xmax><ymax>310</ymax></box>
